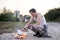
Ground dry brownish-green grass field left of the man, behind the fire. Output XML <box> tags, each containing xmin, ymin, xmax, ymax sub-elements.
<box><xmin>0</xmin><ymin>22</ymin><xmax>25</xmax><ymax>34</ymax></box>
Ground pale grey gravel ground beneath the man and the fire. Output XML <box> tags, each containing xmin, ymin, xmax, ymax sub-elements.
<box><xmin>0</xmin><ymin>22</ymin><xmax>60</xmax><ymax>40</ymax></box>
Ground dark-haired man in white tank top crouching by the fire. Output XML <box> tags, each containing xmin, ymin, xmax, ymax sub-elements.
<box><xmin>24</xmin><ymin>8</ymin><xmax>48</xmax><ymax>37</ymax></box>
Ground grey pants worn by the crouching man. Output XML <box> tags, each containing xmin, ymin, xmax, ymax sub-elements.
<box><xmin>27</xmin><ymin>24</ymin><xmax>48</xmax><ymax>36</ymax></box>
